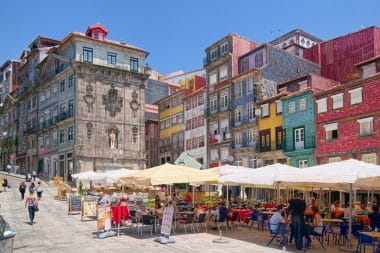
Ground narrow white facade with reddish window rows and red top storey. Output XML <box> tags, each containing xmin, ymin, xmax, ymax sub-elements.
<box><xmin>183</xmin><ymin>76</ymin><xmax>207</xmax><ymax>168</ymax></box>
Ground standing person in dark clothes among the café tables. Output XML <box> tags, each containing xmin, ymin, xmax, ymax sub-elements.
<box><xmin>288</xmin><ymin>193</ymin><xmax>306</xmax><ymax>252</ymax></box>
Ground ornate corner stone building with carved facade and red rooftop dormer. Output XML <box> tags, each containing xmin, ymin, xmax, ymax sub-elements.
<box><xmin>16</xmin><ymin>24</ymin><xmax>149</xmax><ymax>181</ymax></box>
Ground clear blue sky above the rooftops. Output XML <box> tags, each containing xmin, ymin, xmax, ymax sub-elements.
<box><xmin>0</xmin><ymin>0</ymin><xmax>380</xmax><ymax>73</ymax></box>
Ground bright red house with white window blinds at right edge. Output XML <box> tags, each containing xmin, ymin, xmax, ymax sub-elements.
<box><xmin>315</xmin><ymin>57</ymin><xmax>380</xmax><ymax>164</ymax></box>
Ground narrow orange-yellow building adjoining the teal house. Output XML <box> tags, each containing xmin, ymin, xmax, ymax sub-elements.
<box><xmin>257</xmin><ymin>93</ymin><xmax>287</xmax><ymax>166</ymax></box>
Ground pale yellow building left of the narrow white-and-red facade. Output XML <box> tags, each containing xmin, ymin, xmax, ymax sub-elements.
<box><xmin>156</xmin><ymin>90</ymin><xmax>184</xmax><ymax>164</ymax></box>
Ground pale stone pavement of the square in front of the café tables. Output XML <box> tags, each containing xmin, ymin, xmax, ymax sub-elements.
<box><xmin>0</xmin><ymin>174</ymin><xmax>344</xmax><ymax>253</ymax></box>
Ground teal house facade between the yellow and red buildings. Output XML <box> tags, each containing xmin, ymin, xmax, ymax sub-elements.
<box><xmin>282</xmin><ymin>90</ymin><xmax>315</xmax><ymax>167</ymax></box>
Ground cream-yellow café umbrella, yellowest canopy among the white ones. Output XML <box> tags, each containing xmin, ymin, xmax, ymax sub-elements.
<box><xmin>119</xmin><ymin>163</ymin><xmax>219</xmax><ymax>185</ymax></box>
